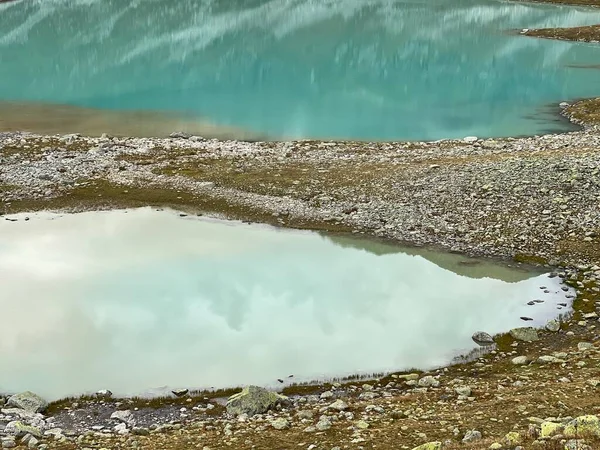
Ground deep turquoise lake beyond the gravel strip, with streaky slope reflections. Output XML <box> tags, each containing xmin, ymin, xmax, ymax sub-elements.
<box><xmin>0</xmin><ymin>0</ymin><xmax>600</xmax><ymax>140</ymax></box>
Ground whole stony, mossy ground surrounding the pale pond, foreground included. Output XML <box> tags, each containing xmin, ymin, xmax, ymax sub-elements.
<box><xmin>0</xmin><ymin>100</ymin><xmax>600</xmax><ymax>450</ymax></box>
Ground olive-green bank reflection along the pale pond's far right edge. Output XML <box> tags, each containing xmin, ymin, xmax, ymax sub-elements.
<box><xmin>324</xmin><ymin>235</ymin><xmax>544</xmax><ymax>283</ymax></box>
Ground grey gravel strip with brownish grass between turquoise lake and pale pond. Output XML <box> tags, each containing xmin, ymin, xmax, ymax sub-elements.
<box><xmin>0</xmin><ymin>101</ymin><xmax>600</xmax><ymax>265</ymax></box>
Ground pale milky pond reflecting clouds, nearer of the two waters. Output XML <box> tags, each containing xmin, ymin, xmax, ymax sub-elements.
<box><xmin>0</xmin><ymin>208</ymin><xmax>571</xmax><ymax>399</ymax></box>
